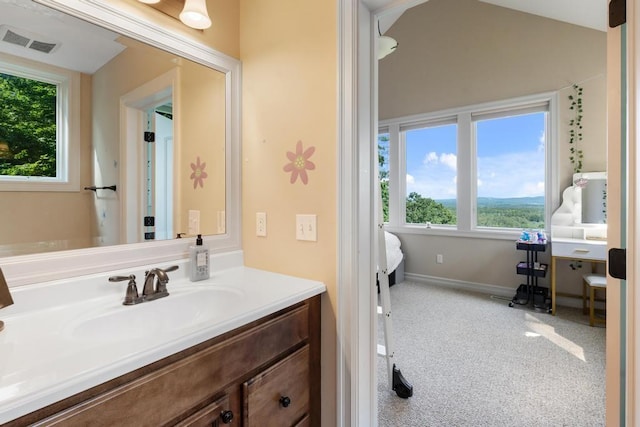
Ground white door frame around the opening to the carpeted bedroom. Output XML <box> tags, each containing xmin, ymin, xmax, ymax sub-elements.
<box><xmin>337</xmin><ymin>0</ymin><xmax>640</xmax><ymax>426</ymax></box>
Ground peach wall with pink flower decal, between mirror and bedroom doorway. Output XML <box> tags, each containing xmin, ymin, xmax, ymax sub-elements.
<box><xmin>240</xmin><ymin>0</ymin><xmax>337</xmax><ymax>426</ymax></box>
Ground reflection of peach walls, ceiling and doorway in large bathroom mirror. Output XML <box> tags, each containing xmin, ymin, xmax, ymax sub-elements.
<box><xmin>0</xmin><ymin>0</ymin><xmax>228</xmax><ymax>256</ymax></box>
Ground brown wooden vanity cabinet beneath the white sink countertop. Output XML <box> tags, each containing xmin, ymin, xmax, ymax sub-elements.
<box><xmin>7</xmin><ymin>296</ymin><xmax>320</xmax><ymax>427</ymax></box>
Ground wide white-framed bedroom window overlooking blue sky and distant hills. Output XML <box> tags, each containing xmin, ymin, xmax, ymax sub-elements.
<box><xmin>379</xmin><ymin>94</ymin><xmax>556</xmax><ymax>236</ymax></box>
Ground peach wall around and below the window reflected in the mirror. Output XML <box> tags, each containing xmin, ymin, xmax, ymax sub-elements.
<box><xmin>0</xmin><ymin>54</ymin><xmax>94</xmax><ymax>256</ymax></box>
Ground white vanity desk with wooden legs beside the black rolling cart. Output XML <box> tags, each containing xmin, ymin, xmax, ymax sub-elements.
<box><xmin>551</xmin><ymin>238</ymin><xmax>607</xmax><ymax>316</ymax></box>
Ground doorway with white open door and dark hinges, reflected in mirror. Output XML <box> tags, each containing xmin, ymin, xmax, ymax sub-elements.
<box><xmin>120</xmin><ymin>69</ymin><xmax>178</xmax><ymax>243</ymax></box>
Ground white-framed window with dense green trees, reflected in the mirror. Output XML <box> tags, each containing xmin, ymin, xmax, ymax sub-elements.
<box><xmin>0</xmin><ymin>58</ymin><xmax>79</xmax><ymax>191</ymax></box>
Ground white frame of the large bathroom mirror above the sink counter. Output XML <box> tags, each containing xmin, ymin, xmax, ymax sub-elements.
<box><xmin>0</xmin><ymin>0</ymin><xmax>241</xmax><ymax>287</ymax></box>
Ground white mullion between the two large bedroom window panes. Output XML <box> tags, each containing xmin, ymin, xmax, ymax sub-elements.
<box><xmin>457</xmin><ymin>113</ymin><xmax>477</xmax><ymax>231</ymax></box>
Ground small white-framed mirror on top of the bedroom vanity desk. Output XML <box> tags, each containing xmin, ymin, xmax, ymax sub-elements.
<box><xmin>573</xmin><ymin>172</ymin><xmax>607</xmax><ymax>224</ymax></box>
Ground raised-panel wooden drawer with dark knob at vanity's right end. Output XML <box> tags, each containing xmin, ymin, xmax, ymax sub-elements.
<box><xmin>243</xmin><ymin>345</ymin><xmax>309</xmax><ymax>427</ymax></box>
